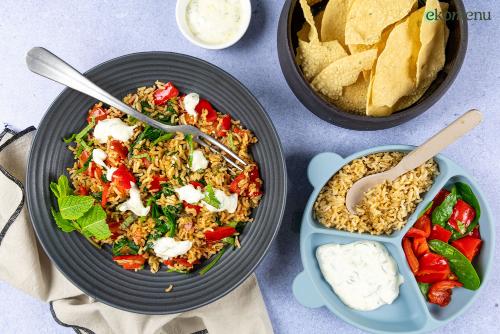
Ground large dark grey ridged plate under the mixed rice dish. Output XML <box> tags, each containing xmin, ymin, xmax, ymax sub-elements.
<box><xmin>26</xmin><ymin>52</ymin><xmax>286</xmax><ymax>314</ymax></box>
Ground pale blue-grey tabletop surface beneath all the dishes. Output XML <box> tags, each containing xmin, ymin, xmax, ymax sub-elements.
<box><xmin>0</xmin><ymin>0</ymin><xmax>500</xmax><ymax>334</ymax></box>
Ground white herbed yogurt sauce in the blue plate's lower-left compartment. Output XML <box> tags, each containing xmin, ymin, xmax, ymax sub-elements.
<box><xmin>316</xmin><ymin>241</ymin><xmax>404</xmax><ymax>311</ymax></box>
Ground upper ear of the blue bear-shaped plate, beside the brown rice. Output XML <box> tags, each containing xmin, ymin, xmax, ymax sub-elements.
<box><xmin>307</xmin><ymin>152</ymin><xmax>345</xmax><ymax>188</ymax></box>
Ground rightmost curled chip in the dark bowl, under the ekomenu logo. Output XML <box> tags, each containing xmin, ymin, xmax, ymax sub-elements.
<box><xmin>416</xmin><ymin>0</ymin><xmax>448</xmax><ymax>85</ymax></box>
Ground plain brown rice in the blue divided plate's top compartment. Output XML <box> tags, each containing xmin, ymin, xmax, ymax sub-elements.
<box><xmin>314</xmin><ymin>152</ymin><xmax>439</xmax><ymax>235</ymax></box>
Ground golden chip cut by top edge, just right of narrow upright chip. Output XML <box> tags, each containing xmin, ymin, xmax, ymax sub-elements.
<box><xmin>320</xmin><ymin>0</ymin><xmax>354</xmax><ymax>46</ymax></box>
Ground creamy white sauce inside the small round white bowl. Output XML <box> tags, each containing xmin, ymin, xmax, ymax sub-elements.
<box><xmin>186</xmin><ymin>0</ymin><xmax>243</xmax><ymax>45</ymax></box>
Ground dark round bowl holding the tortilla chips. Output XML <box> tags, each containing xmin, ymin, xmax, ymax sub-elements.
<box><xmin>278</xmin><ymin>0</ymin><xmax>467</xmax><ymax>130</ymax></box>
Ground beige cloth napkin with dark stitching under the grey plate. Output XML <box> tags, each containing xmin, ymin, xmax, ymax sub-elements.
<box><xmin>0</xmin><ymin>127</ymin><xmax>273</xmax><ymax>334</ymax></box>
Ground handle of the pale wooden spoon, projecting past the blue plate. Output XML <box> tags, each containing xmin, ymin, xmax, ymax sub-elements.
<box><xmin>391</xmin><ymin>109</ymin><xmax>483</xmax><ymax>179</ymax></box>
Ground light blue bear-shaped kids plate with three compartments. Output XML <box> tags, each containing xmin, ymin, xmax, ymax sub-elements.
<box><xmin>293</xmin><ymin>145</ymin><xmax>495</xmax><ymax>333</ymax></box>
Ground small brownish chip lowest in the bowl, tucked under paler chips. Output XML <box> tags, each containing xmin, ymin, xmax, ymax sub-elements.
<box><xmin>332</xmin><ymin>75</ymin><xmax>368</xmax><ymax>114</ymax></box>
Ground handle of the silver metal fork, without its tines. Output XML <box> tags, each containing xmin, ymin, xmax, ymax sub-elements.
<box><xmin>26</xmin><ymin>47</ymin><xmax>182</xmax><ymax>132</ymax></box>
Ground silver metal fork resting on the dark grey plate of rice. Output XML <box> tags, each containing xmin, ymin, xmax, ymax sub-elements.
<box><xmin>26</xmin><ymin>47</ymin><xmax>248</xmax><ymax>170</ymax></box>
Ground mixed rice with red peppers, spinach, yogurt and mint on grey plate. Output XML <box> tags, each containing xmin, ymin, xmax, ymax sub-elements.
<box><xmin>51</xmin><ymin>81</ymin><xmax>262</xmax><ymax>272</ymax></box>
